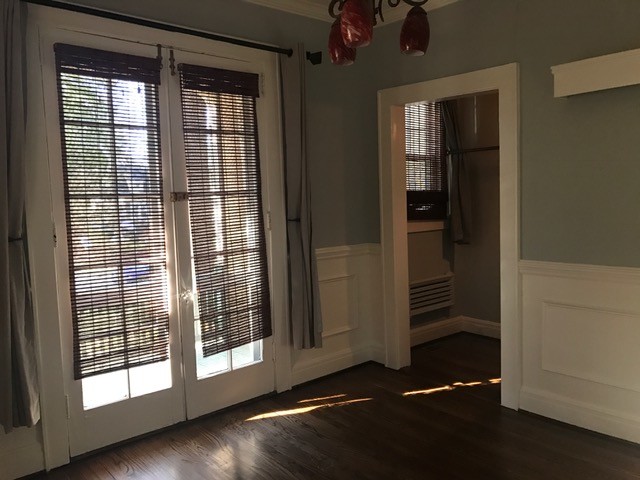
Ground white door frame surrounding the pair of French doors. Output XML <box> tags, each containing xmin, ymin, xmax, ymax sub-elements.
<box><xmin>26</xmin><ymin>5</ymin><xmax>291</xmax><ymax>470</ymax></box>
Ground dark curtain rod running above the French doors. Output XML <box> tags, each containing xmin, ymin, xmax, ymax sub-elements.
<box><xmin>21</xmin><ymin>0</ymin><xmax>293</xmax><ymax>57</ymax></box>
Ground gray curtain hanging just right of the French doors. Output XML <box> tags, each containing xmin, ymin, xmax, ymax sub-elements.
<box><xmin>280</xmin><ymin>44</ymin><xmax>322</xmax><ymax>349</ymax></box>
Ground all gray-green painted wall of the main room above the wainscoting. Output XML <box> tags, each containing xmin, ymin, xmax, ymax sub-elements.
<box><xmin>58</xmin><ymin>0</ymin><xmax>640</xmax><ymax>267</ymax></box>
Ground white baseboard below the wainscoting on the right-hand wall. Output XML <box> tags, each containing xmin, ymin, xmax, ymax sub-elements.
<box><xmin>520</xmin><ymin>387</ymin><xmax>640</xmax><ymax>443</ymax></box>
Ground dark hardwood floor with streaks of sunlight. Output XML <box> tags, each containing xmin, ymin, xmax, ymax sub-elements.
<box><xmin>32</xmin><ymin>334</ymin><xmax>640</xmax><ymax>480</ymax></box>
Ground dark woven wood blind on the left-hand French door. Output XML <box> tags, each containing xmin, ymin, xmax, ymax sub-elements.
<box><xmin>55</xmin><ymin>44</ymin><xmax>169</xmax><ymax>379</ymax></box>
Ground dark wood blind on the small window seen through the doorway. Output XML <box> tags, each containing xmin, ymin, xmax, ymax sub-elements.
<box><xmin>405</xmin><ymin>103</ymin><xmax>448</xmax><ymax>220</ymax></box>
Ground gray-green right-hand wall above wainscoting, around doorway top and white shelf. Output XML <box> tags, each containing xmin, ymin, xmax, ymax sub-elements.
<box><xmin>361</xmin><ymin>0</ymin><xmax>640</xmax><ymax>267</ymax></box>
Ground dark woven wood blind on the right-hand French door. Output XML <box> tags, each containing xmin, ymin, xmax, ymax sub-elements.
<box><xmin>179</xmin><ymin>64</ymin><xmax>271</xmax><ymax>357</ymax></box>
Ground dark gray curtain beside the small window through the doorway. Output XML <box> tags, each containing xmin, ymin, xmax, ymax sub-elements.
<box><xmin>442</xmin><ymin>100</ymin><xmax>472</xmax><ymax>244</ymax></box>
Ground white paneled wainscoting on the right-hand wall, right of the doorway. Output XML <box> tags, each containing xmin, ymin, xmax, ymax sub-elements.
<box><xmin>520</xmin><ymin>261</ymin><xmax>640</xmax><ymax>443</ymax></box>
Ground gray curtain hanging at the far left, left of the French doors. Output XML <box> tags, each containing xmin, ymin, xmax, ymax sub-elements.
<box><xmin>0</xmin><ymin>0</ymin><xmax>40</xmax><ymax>432</ymax></box>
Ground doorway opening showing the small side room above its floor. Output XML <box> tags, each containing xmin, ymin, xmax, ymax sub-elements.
<box><xmin>405</xmin><ymin>92</ymin><xmax>500</xmax><ymax>347</ymax></box>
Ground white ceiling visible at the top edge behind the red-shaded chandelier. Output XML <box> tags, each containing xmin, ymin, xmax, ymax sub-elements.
<box><xmin>245</xmin><ymin>0</ymin><xmax>458</xmax><ymax>23</ymax></box>
